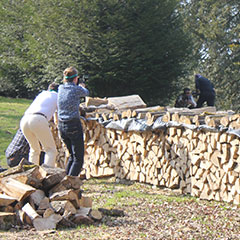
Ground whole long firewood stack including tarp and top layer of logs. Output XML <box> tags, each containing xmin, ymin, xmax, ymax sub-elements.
<box><xmin>53</xmin><ymin>95</ymin><xmax>240</xmax><ymax>204</ymax></box>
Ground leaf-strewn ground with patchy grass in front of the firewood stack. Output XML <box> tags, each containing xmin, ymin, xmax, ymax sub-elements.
<box><xmin>0</xmin><ymin>178</ymin><xmax>240</xmax><ymax>240</ymax></box>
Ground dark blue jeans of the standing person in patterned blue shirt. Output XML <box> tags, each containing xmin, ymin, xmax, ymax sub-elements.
<box><xmin>58</xmin><ymin>119</ymin><xmax>84</xmax><ymax>176</ymax></box>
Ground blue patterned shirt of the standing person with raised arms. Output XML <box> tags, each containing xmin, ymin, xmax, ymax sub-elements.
<box><xmin>57</xmin><ymin>82</ymin><xmax>89</xmax><ymax>121</ymax></box>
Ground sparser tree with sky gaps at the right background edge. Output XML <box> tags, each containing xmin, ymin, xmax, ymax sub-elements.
<box><xmin>183</xmin><ymin>0</ymin><xmax>240</xmax><ymax>109</ymax></box>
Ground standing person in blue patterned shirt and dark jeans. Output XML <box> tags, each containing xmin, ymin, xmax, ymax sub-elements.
<box><xmin>57</xmin><ymin>67</ymin><xmax>89</xmax><ymax>176</ymax></box>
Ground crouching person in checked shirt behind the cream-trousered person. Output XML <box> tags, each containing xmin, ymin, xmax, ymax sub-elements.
<box><xmin>5</xmin><ymin>128</ymin><xmax>44</xmax><ymax>167</ymax></box>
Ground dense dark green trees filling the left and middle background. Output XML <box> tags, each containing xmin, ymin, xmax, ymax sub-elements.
<box><xmin>0</xmin><ymin>0</ymin><xmax>191</xmax><ymax>104</ymax></box>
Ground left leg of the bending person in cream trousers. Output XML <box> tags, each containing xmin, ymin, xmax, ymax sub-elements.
<box><xmin>20</xmin><ymin>115</ymin><xmax>40</xmax><ymax>165</ymax></box>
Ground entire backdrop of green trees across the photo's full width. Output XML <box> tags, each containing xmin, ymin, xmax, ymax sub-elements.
<box><xmin>0</xmin><ymin>0</ymin><xmax>240</xmax><ymax>108</ymax></box>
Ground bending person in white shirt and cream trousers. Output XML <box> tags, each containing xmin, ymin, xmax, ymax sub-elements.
<box><xmin>20</xmin><ymin>83</ymin><xmax>58</xmax><ymax>167</ymax></box>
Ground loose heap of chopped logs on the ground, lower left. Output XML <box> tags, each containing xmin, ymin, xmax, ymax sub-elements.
<box><xmin>0</xmin><ymin>163</ymin><xmax>102</xmax><ymax>230</ymax></box>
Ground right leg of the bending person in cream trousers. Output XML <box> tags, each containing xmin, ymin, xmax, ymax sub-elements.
<box><xmin>30</xmin><ymin>115</ymin><xmax>57</xmax><ymax>167</ymax></box>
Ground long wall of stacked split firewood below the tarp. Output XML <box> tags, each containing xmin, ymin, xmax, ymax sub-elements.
<box><xmin>53</xmin><ymin>113</ymin><xmax>240</xmax><ymax>204</ymax></box>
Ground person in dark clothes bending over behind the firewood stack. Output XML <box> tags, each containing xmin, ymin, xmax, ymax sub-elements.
<box><xmin>195</xmin><ymin>74</ymin><xmax>215</xmax><ymax>108</ymax></box>
